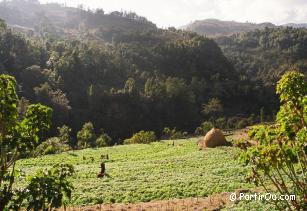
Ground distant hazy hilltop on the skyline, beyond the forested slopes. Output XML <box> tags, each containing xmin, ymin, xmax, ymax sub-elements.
<box><xmin>181</xmin><ymin>19</ymin><xmax>277</xmax><ymax>37</ymax></box>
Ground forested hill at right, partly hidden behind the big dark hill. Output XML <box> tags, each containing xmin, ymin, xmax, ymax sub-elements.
<box><xmin>215</xmin><ymin>28</ymin><xmax>307</xmax><ymax>87</ymax></box>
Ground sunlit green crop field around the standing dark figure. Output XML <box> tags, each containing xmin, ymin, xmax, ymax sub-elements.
<box><xmin>17</xmin><ymin>139</ymin><xmax>254</xmax><ymax>205</ymax></box>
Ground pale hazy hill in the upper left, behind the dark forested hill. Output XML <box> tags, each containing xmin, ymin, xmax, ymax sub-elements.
<box><xmin>0</xmin><ymin>0</ymin><xmax>157</xmax><ymax>42</ymax></box>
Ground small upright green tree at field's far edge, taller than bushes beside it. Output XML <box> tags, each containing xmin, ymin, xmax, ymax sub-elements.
<box><xmin>77</xmin><ymin>122</ymin><xmax>96</xmax><ymax>149</ymax></box>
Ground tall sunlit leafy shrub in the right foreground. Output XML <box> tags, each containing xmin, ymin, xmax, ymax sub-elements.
<box><xmin>241</xmin><ymin>71</ymin><xmax>307</xmax><ymax>210</ymax></box>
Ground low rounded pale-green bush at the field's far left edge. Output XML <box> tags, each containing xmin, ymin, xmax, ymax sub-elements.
<box><xmin>34</xmin><ymin>137</ymin><xmax>70</xmax><ymax>156</ymax></box>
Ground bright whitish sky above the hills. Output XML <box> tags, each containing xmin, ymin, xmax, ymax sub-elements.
<box><xmin>40</xmin><ymin>0</ymin><xmax>307</xmax><ymax>27</ymax></box>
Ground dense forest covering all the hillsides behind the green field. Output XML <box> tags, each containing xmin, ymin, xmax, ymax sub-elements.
<box><xmin>0</xmin><ymin>0</ymin><xmax>307</xmax><ymax>145</ymax></box>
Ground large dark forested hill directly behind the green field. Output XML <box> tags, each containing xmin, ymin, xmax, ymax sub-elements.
<box><xmin>0</xmin><ymin>2</ymin><xmax>266</xmax><ymax>142</ymax></box>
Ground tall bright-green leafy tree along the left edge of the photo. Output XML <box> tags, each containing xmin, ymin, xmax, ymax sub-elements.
<box><xmin>0</xmin><ymin>75</ymin><xmax>63</xmax><ymax>210</ymax></box>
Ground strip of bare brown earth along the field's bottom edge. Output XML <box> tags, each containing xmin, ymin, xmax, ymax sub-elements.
<box><xmin>59</xmin><ymin>193</ymin><xmax>243</xmax><ymax>211</ymax></box>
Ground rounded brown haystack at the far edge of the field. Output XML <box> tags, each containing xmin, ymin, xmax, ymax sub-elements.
<box><xmin>198</xmin><ymin>128</ymin><xmax>228</xmax><ymax>149</ymax></box>
